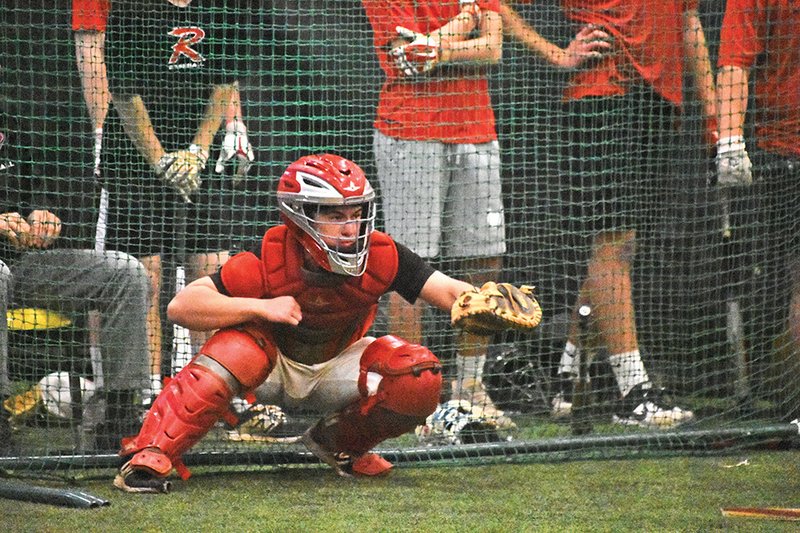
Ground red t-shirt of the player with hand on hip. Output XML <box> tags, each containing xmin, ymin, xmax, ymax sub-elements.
<box><xmin>561</xmin><ymin>0</ymin><xmax>698</xmax><ymax>106</ymax></box>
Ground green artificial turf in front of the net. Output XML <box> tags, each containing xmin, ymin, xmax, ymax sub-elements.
<box><xmin>0</xmin><ymin>450</ymin><xmax>800</xmax><ymax>532</ymax></box>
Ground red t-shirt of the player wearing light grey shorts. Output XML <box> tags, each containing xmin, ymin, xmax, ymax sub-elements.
<box><xmin>362</xmin><ymin>0</ymin><xmax>500</xmax><ymax>144</ymax></box>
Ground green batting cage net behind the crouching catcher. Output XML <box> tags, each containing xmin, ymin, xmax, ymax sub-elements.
<box><xmin>0</xmin><ymin>0</ymin><xmax>800</xmax><ymax>478</ymax></box>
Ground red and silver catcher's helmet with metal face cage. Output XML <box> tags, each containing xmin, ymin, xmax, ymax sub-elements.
<box><xmin>278</xmin><ymin>154</ymin><xmax>375</xmax><ymax>276</ymax></box>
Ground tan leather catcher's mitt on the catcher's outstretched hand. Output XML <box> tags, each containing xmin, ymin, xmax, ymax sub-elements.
<box><xmin>450</xmin><ymin>281</ymin><xmax>542</xmax><ymax>335</ymax></box>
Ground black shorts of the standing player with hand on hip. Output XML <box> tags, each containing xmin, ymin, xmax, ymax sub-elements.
<box><xmin>561</xmin><ymin>87</ymin><xmax>676</xmax><ymax>232</ymax></box>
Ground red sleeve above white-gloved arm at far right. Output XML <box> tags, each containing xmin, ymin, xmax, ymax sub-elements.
<box><xmin>717</xmin><ymin>0</ymin><xmax>766</xmax><ymax>69</ymax></box>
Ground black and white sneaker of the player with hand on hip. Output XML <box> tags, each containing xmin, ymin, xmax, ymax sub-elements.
<box><xmin>612</xmin><ymin>384</ymin><xmax>694</xmax><ymax>429</ymax></box>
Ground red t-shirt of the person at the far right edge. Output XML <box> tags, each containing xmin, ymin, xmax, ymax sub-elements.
<box><xmin>717</xmin><ymin>0</ymin><xmax>800</xmax><ymax>156</ymax></box>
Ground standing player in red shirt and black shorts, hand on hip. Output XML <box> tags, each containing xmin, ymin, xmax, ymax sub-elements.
<box><xmin>501</xmin><ymin>0</ymin><xmax>717</xmax><ymax>428</ymax></box>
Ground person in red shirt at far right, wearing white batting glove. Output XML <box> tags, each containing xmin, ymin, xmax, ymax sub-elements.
<box><xmin>717</xmin><ymin>0</ymin><xmax>800</xmax><ymax>420</ymax></box>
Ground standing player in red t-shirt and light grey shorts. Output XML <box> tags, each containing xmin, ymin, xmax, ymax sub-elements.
<box><xmin>362</xmin><ymin>0</ymin><xmax>514</xmax><ymax>428</ymax></box>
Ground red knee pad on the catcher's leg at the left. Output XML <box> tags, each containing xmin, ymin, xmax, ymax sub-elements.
<box><xmin>198</xmin><ymin>326</ymin><xmax>278</xmax><ymax>391</ymax></box>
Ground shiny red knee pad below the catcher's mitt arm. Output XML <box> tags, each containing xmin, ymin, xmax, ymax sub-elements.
<box><xmin>358</xmin><ymin>335</ymin><xmax>442</xmax><ymax>418</ymax></box>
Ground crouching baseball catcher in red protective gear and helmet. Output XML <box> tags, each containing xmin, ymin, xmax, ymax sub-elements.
<box><xmin>114</xmin><ymin>154</ymin><xmax>541</xmax><ymax>492</ymax></box>
